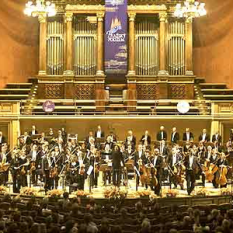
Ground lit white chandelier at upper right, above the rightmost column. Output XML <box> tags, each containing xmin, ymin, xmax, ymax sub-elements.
<box><xmin>174</xmin><ymin>0</ymin><xmax>206</xmax><ymax>19</ymax></box>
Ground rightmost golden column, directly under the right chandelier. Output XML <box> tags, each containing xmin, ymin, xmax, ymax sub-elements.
<box><xmin>185</xmin><ymin>19</ymin><xmax>193</xmax><ymax>75</ymax></box>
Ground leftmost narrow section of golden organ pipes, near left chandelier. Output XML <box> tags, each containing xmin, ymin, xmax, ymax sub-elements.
<box><xmin>47</xmin><ymin>17</ymin><xmax>64</xmax><ymax>75</ymax></box>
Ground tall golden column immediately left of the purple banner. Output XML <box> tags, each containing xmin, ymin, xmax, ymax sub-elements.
<box><xmin>96</xmin><ymin>13</ymin><xmax>104</xmax><ymax>76</ymax></box>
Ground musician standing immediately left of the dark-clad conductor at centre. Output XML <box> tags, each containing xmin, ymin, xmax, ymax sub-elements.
<box><xmin>101</xmin><ymin>144</ymin><xmax>112</xmax><ymax>185</ymax></box>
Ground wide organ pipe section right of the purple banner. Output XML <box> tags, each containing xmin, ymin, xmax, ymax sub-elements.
<box><xmin>135</xmin><ymin>17</ymin><xmax>159</xmax><ymax>75</ymax></box>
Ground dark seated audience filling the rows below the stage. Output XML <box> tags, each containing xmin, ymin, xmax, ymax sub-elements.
<box><xmin>0</xmin><ymin>196</ymin><xmax>233</xmax><ymax>233</ymax></box>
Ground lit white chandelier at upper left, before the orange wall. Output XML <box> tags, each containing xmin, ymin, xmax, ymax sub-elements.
<box><xmin>24</xmin><ymin>0</ymin><xmax>57</xmax><ymax>17</ymax></box>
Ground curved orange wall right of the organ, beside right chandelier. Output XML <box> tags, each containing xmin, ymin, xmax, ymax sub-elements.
<box><xmin>193</xmin><ymin>0</ymin><xmax>233</xmax><ymax>88</ymax></box>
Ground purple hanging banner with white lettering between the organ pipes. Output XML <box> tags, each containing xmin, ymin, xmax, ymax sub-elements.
<box><xmin>105</xmin><ymin>0</ymin><xmax>128</xmax><ymax>75</ymax></box>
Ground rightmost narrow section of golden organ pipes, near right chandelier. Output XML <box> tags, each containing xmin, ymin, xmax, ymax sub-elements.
<box><xmin>168</xmin><ymin>19</ymin><xmax>185</xmax><ymax>75</ymax></box>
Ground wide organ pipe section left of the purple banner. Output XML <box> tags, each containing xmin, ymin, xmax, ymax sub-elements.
<box><xmin>73</xmin><ymin>16</ymin><xmax>97</xmax><ymax>75</ymax></box>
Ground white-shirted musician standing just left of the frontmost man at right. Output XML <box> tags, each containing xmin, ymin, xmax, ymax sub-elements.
<box><xmin>168</xmin><ymin>147</ymin><xmax>183</xmax><ymax>189</ymax></box>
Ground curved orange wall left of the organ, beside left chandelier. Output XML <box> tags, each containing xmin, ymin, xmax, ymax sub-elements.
<box><xmin>0</xmin><ymin>0</ymin><xmax>39</xmax><ymax>88</ymax></box>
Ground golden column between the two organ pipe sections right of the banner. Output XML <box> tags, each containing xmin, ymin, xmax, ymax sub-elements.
<box><xmin>159</xmin><ymin>12</ymin><xmax>168</xmax><ymax>75</ymax></box>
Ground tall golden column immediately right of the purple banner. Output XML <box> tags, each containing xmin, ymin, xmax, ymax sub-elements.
<box><xmin>128</xmin><ymin>13</ymin><xmax>136</xmax><ymax>76</ymax></box>
